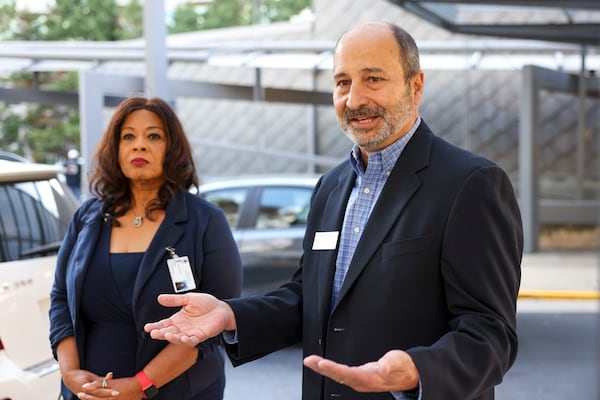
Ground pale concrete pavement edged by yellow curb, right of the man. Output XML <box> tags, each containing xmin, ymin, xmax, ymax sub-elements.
<box><xmin>519</xmin><ymin>250</ymin><xmax>600</xmax><ymax>300</ymax></box>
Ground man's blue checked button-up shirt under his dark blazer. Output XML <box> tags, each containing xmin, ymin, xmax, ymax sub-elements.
<box><xmin>331</xmin><ymin>117</ymin><xmax>421</xmax><ymax>400</ymax></box>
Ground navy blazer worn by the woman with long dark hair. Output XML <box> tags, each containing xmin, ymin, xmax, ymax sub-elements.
<box><xmin>50</xmin><ymin>190</ymin><xmax>242</xmax><ymax>399</ymax></box>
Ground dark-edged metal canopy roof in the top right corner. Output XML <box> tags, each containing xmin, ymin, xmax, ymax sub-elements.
<box><xmin>389</xmin><ymin>0</ymin><xmax>600</xmax><ymax>46</ymax></box>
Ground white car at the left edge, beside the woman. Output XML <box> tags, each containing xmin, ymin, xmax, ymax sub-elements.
<box><xmin>0</xmin><ymin>159</ymin><xmax>78</xmax><ymax>400</ymax></box>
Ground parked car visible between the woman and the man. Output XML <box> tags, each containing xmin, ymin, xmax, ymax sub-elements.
<box><xmin>200</xmin><ymin>176</ymin><xmax>318</xmax><ymax>293</ymax></box>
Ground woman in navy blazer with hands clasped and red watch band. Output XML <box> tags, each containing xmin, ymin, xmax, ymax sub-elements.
<box><xmin>50</xmin><ymin>97</ymin><xmax>242</xmax><ymax>400</ymax></box>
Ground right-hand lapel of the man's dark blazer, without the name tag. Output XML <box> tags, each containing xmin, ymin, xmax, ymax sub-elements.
<box><xmin>334</xmin><ymin>127</ymin><xmax>432</xmax><ymax>303</ymax></box>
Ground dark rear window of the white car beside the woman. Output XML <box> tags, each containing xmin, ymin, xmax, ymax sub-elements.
<box><xmin>0</xmin><ymin>180</ymin><xmax>70</xmax><ymax>261</ymax></box>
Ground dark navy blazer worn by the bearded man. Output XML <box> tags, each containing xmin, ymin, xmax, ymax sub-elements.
<box><xmin>227</xmin><ymin>122</ymin><xmax>523</xmax><ymax>400</ymax></box>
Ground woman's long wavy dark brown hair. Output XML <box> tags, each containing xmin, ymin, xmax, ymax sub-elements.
<box><xmin>89</xmin><ymin>97</ymin><xmax>198</xmax><ymax>226</ymax></box>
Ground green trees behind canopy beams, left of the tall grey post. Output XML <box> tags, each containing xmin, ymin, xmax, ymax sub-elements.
<box><xmin>0</xmin><ymin>0</ymin><xmax>143</xmax><ymax>163</ymax></box>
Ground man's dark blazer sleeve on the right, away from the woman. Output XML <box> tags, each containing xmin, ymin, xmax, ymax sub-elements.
<box><xmin>408</xmin><ymin>165</ymin><xmax>523</xmax><ymax>400</ymax></box>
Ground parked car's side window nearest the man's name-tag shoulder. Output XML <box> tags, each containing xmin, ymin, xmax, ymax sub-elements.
<box><xmin>256</xmin><ymin>187</ymin><xmax>312</xmax><ymax>229</ymax></box>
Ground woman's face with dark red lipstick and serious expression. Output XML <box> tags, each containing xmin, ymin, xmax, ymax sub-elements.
<box><xmin>119</xmin><ymin>110</ymin><xmax>167</xmax><ymax>186</ymax></box>
